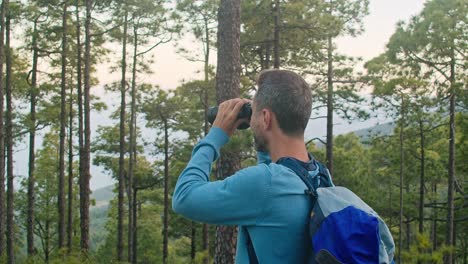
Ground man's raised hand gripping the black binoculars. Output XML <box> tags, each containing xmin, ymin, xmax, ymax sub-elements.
<box><xmin>213</xmin><ymin>98</ymin><xmax>250</xmax><ymax>136</ymax></box>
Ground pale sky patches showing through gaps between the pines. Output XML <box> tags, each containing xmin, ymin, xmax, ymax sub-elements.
<box><xmin>15</xmin><ymin>0</ymin><xmax>425</xmax><ymax>190</ymax></box>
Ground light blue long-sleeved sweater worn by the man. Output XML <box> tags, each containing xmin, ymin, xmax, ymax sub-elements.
<box><xmin>172</xmin><ymin>127</ymin><xmax>311</xmax><ymax>264</ymax></box>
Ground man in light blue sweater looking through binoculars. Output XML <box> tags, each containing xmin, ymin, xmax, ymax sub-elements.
<box><xmin>172</xmin><ymin>70</ymin><xmax>317</xmax><ymax>264</ymax></box>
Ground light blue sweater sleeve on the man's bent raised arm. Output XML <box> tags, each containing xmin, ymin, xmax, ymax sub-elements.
<box><xmin>172</xmin><ymin>127</ymin><xmax>271</xmax><ymax>225</ymax></box>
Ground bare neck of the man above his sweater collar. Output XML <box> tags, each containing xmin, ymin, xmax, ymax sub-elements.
<box><xmin>269</xmin><ymin>135</ymin><xmax>309</xmax><ymax>162</ymax></box>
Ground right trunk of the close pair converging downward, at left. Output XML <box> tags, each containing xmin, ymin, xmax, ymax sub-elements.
<box><xmin>80</xmin><ymin>0</ymin><xmax>93</xmax><ymax>254</ymax></box>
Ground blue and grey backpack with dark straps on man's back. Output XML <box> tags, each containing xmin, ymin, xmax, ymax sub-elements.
<box><xmin>247</xmin><ymin>157</ymin><xmax>395</xmax><ymax>264</ymax></box>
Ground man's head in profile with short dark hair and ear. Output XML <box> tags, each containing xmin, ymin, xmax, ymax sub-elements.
<box><xmin>250</xmin><ymin>70</ymin><xmax>312</xmax><ymax>150</ymax></box>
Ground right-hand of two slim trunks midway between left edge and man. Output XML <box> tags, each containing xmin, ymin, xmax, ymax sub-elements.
<box><xmin>127</xmin><ymin>22</ymin><xmax>138</xmax><ymax>262</ymax></box>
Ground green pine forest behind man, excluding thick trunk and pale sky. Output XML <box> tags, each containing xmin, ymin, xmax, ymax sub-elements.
<box><xmin>0</xmin><ymin>0</ymin><xmax>468</xmax><ymax>264</ymax></box>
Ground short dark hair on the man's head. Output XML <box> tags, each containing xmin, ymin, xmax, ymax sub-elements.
<box><xmin>255</xmin><ymin>69</ymin><xmax>312</xmax><ymax>136</ymax></box>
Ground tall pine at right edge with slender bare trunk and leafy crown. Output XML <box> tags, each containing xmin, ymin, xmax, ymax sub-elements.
<box><xmin>388</xmin><ymin>0</ymin><xmax>468</xmax><ymax>263</ymax></box>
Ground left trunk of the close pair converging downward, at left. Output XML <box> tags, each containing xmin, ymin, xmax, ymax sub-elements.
<box><xmin>75</xmin><ymin>0</ymin><xmax>84</xmax><ymax>252</ymax></box>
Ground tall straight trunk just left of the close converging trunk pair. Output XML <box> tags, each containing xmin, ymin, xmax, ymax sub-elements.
<box><xmin>57</xmin><ymin>1</ymin><xmax>68</xmax><ymax>249</ymax></box>
